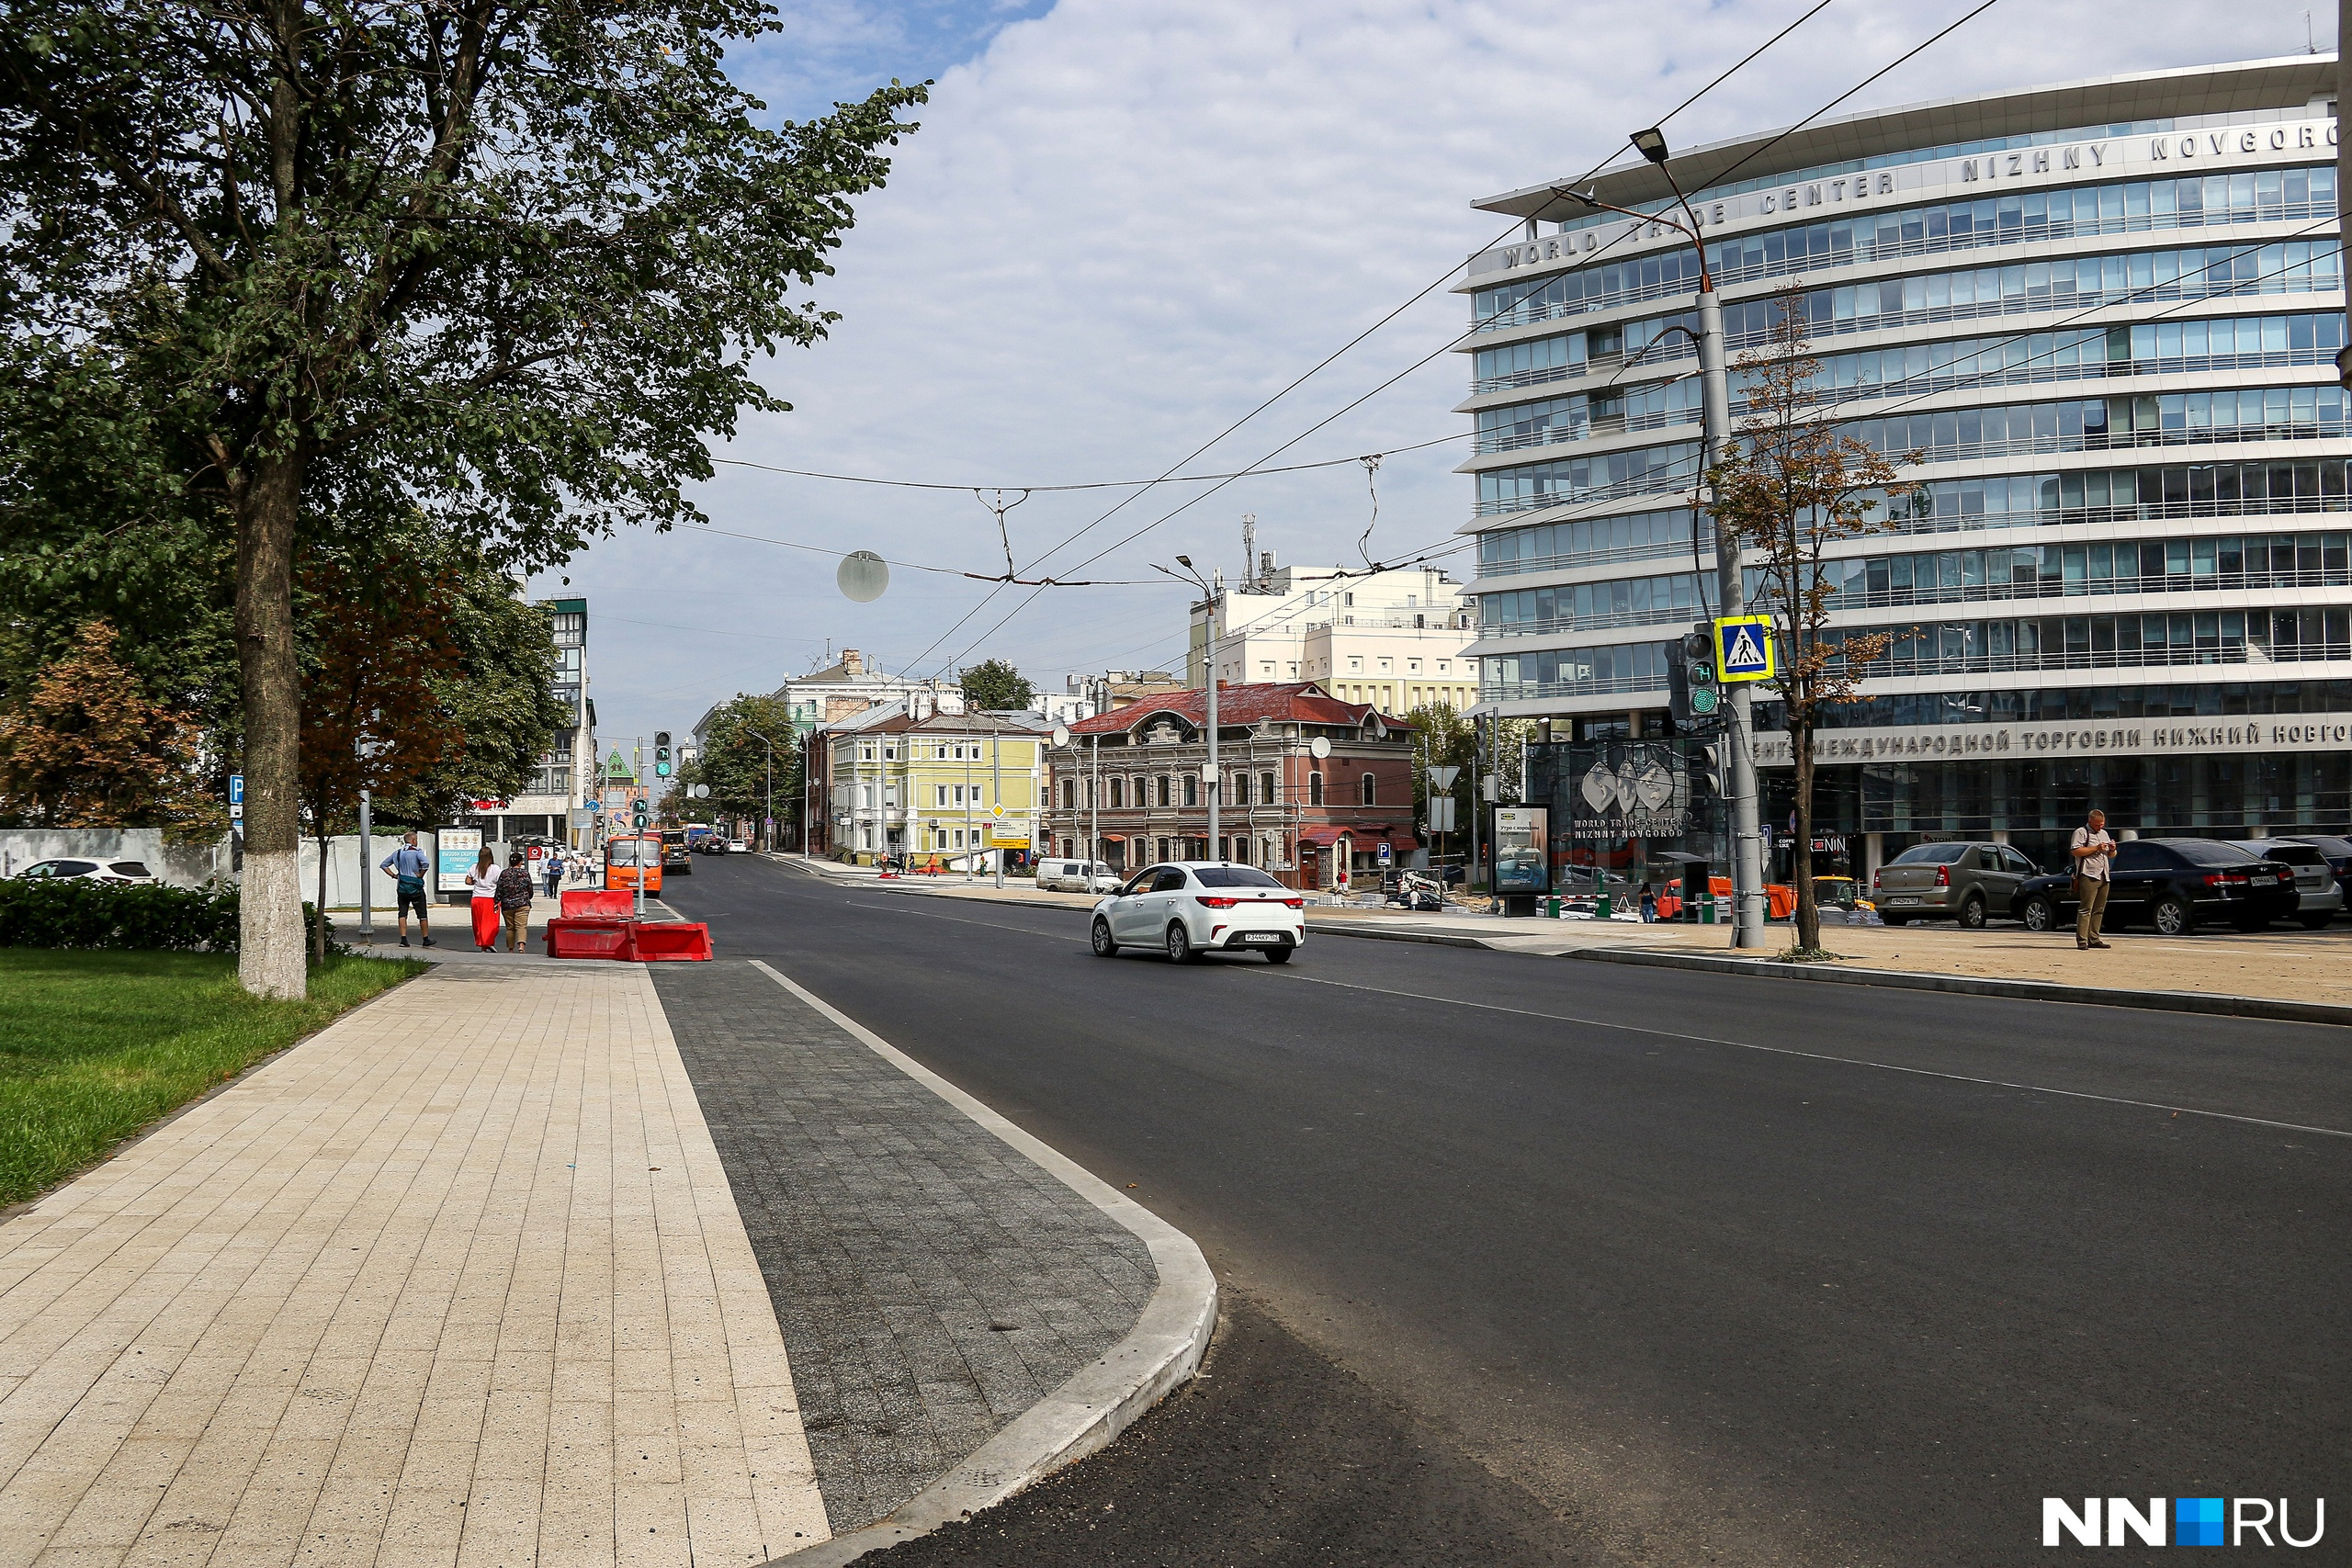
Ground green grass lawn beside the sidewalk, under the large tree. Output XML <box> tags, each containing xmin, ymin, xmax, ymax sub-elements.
<box><xmin>0</xmin><ymin>947</ymin><xmax>425</xmax><ymax>1203</ymax></box>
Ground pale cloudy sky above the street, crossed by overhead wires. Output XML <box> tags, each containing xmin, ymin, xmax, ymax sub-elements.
<box><xmin>534</xmin><ymin>0</ymin><xmax>2334</xmax><ymax>748</ymax></box>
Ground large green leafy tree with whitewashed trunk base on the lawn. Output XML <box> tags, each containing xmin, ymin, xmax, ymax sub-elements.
<box><xmin>0</xmin><ymin>0</ymin><xmax>924</xmax><ymax>997</ymax></box>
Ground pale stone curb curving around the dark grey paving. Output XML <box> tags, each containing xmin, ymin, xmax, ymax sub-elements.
<box><xmin>751</xmin><ymin>959</ymin><xmax>1216</xmax><ymax>1568</ymax></box>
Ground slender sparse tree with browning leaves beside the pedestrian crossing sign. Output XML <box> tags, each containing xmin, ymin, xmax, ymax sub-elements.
<box><xmin>1708</xmin><ymin>289</ymin><xmax>1922</xmax><ymax>954</ymax></box>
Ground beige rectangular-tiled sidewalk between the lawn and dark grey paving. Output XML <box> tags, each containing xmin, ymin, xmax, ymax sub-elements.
<box><xmin>0</xmin><ymin>962</ymin><xmax>826</xmax><ymax>1568</ymax></box>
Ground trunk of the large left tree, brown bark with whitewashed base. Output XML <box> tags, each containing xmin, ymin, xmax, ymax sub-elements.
<box><xmin>238</xmin><ymin>454</ymin><xmax>308</xmax><ymax>1001</ymax></box>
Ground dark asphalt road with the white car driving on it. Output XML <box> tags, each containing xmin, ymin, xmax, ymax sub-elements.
<box><xmin>671</xmin><ymin>858</ymin><xmax>2352</xmax><ymax>1568</ymax></box>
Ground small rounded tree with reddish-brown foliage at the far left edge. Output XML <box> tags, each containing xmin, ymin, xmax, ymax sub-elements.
<box><xmin>0</xmin><ymin>621</ymin><xmax>198</xmax><ymax>828</ymax></box>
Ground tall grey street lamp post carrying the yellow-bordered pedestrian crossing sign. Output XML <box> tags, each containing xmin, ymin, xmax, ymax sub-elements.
<box><xmin>1557</xmin><ymin>130</ymin><xmax>1764</xmax><ymax>947</ymax></box>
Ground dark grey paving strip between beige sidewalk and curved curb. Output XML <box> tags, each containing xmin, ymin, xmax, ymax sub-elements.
<box><xmin>654</xmin><ymin>962</ymin><xmax>1158</xmax><ymax>1533</ymax></box>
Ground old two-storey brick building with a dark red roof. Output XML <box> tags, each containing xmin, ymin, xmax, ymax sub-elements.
<box><xmin>1042</xmin><ymin>682</ymin><xmax>1419</xmax><ymax>888</ymax></box>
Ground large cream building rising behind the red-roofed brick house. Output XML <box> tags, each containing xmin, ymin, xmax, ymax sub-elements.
<box><xmin>1185</xmin><ymin>552</ymin><xmax>1477</xmax><ymax>712</ymax></box>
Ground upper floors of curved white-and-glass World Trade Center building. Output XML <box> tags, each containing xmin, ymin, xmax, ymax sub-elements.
<box><xmin>1461</xmin><ymin>54</ymin><xmax>2352</xmax><ymax>877</ymax></box>
